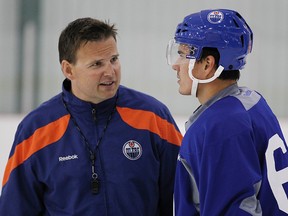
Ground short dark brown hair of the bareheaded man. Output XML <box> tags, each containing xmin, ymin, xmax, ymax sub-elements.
<box><xmin>58</xmin><ymin>17</ymin><xmax>117</xmax><ymax>63</ymax></box>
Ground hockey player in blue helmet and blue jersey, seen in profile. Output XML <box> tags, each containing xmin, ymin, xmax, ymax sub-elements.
<box><xmin>167</xmin><ymin>9</ymin><xmax>288</xmax><ymax>216</ymax></box>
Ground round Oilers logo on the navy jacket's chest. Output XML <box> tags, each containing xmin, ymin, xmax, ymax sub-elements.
<box><xmin>122</xmin><ymin>140</ymin><xmax>142</xmax><ymax>160</ymax></box>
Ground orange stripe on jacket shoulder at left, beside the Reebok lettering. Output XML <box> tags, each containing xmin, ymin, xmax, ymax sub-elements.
<box><xmin>2</xmin><ymin>115</ymin><xmax>70</xmax><ymax>186</ymax></box>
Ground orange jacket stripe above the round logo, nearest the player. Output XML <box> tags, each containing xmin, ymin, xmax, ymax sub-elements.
<box><xmin>117</xmin><ymin>107</ymin><xmax>182</xmax><ymax>146</ymax></box>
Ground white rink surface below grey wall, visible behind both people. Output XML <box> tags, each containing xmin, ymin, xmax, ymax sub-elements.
<box><xmin>0</xmin><ymin>115</ymin><xmax>288</xmax><ymax>193</ymax></box>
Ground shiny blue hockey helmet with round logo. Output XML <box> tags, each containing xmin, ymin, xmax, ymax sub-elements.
<box><xmin>170</xmin><ymin>9</ymin><xmax>253</xmax><ymax>70</ymax></box>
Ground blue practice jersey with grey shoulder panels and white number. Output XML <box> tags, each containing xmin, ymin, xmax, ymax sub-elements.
<box><xmin>175</xmin><ymin>84</ymin><xmax>288</xmax><ymax>216</ymax></box>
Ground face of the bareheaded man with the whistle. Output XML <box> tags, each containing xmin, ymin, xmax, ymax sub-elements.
<box><xmin>62</xmin><ymin>37</ymin><xmax>121</xmax><ymax>104</ymax></box>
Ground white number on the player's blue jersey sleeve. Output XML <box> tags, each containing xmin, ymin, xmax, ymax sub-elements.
<box><xmin>265</xmin><ymin>134</ymin><xmax>288</xmax><ymax>213</ymax></box>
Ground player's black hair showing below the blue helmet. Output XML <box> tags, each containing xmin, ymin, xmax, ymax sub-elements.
<box><xmin>199</xmin><ymin>47</ymin><xmax>240</xmax><ymax>80</ymax></box>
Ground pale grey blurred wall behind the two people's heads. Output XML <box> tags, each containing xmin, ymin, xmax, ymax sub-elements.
<box><xmin>0</xmin><ymin>0</ymin><xmax>288</xmax><ymax>118</ymax></box>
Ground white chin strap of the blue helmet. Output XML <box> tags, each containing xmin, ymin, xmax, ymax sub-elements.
<box><xmin>188</xmin><ymin>59</ymin><xmax>224</xmax><ymax>97</ymax></box>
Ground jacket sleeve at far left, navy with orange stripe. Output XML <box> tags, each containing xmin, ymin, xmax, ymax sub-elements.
<box><xmin>0</xmin><ymin>115</ymin><xmax>70</xmax><ymax>216</ymax></box>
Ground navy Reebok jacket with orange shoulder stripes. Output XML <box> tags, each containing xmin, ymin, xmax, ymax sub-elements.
<box><xmin>0</xmin><ymin>80</ymin><xmax>182</xmax><ymax>216</ymax></box>
